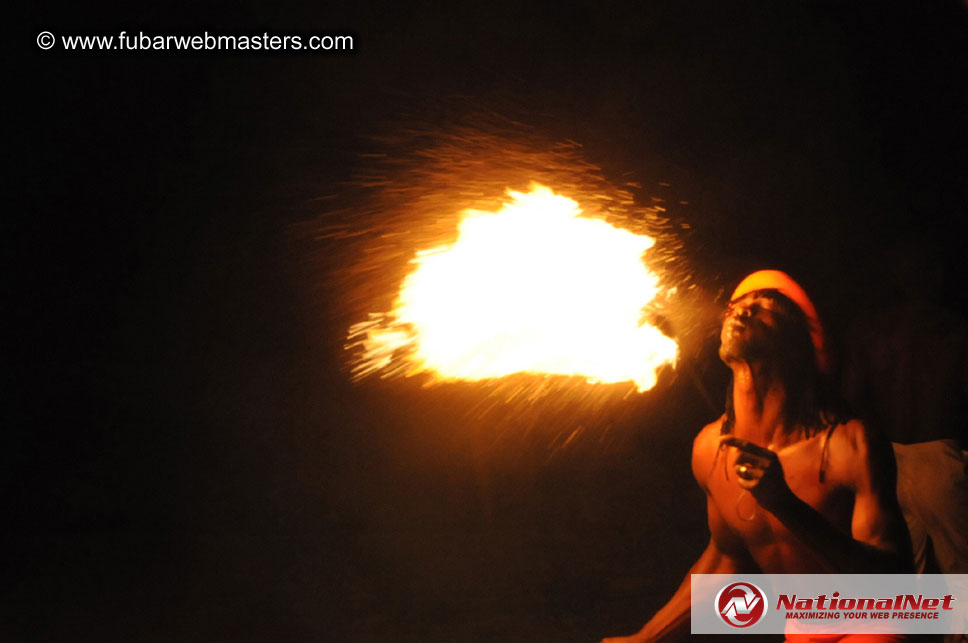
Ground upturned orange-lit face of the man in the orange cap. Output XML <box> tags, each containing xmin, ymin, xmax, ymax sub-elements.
<box><xmin>719</xmin><ymin>290</ymin><xmax>787</xmax><ymax>364</ymax></box>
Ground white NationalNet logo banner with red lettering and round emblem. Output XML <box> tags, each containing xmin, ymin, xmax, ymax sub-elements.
<box><xmin>692</xmin><ymin>574</ymin><xmax>968</xmax><ymax>634</ymax></box>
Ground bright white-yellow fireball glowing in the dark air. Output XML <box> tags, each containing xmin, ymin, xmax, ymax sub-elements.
<box><xmin>350</xmin><ymin>184</ymin><xmax>677</xmax><ymax>391</ymax></box>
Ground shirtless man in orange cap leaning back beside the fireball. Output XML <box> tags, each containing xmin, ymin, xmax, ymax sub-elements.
<box><xmin>606</xmin><ymin>270</ymin><xmax>911</xmax><ymax>643</ymax></box>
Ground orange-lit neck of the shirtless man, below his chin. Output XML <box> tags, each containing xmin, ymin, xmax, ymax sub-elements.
<box><xmin>730</xmin><ymin>362</ymin><xmax>786</xmax><ymax>446</ymax></box>
